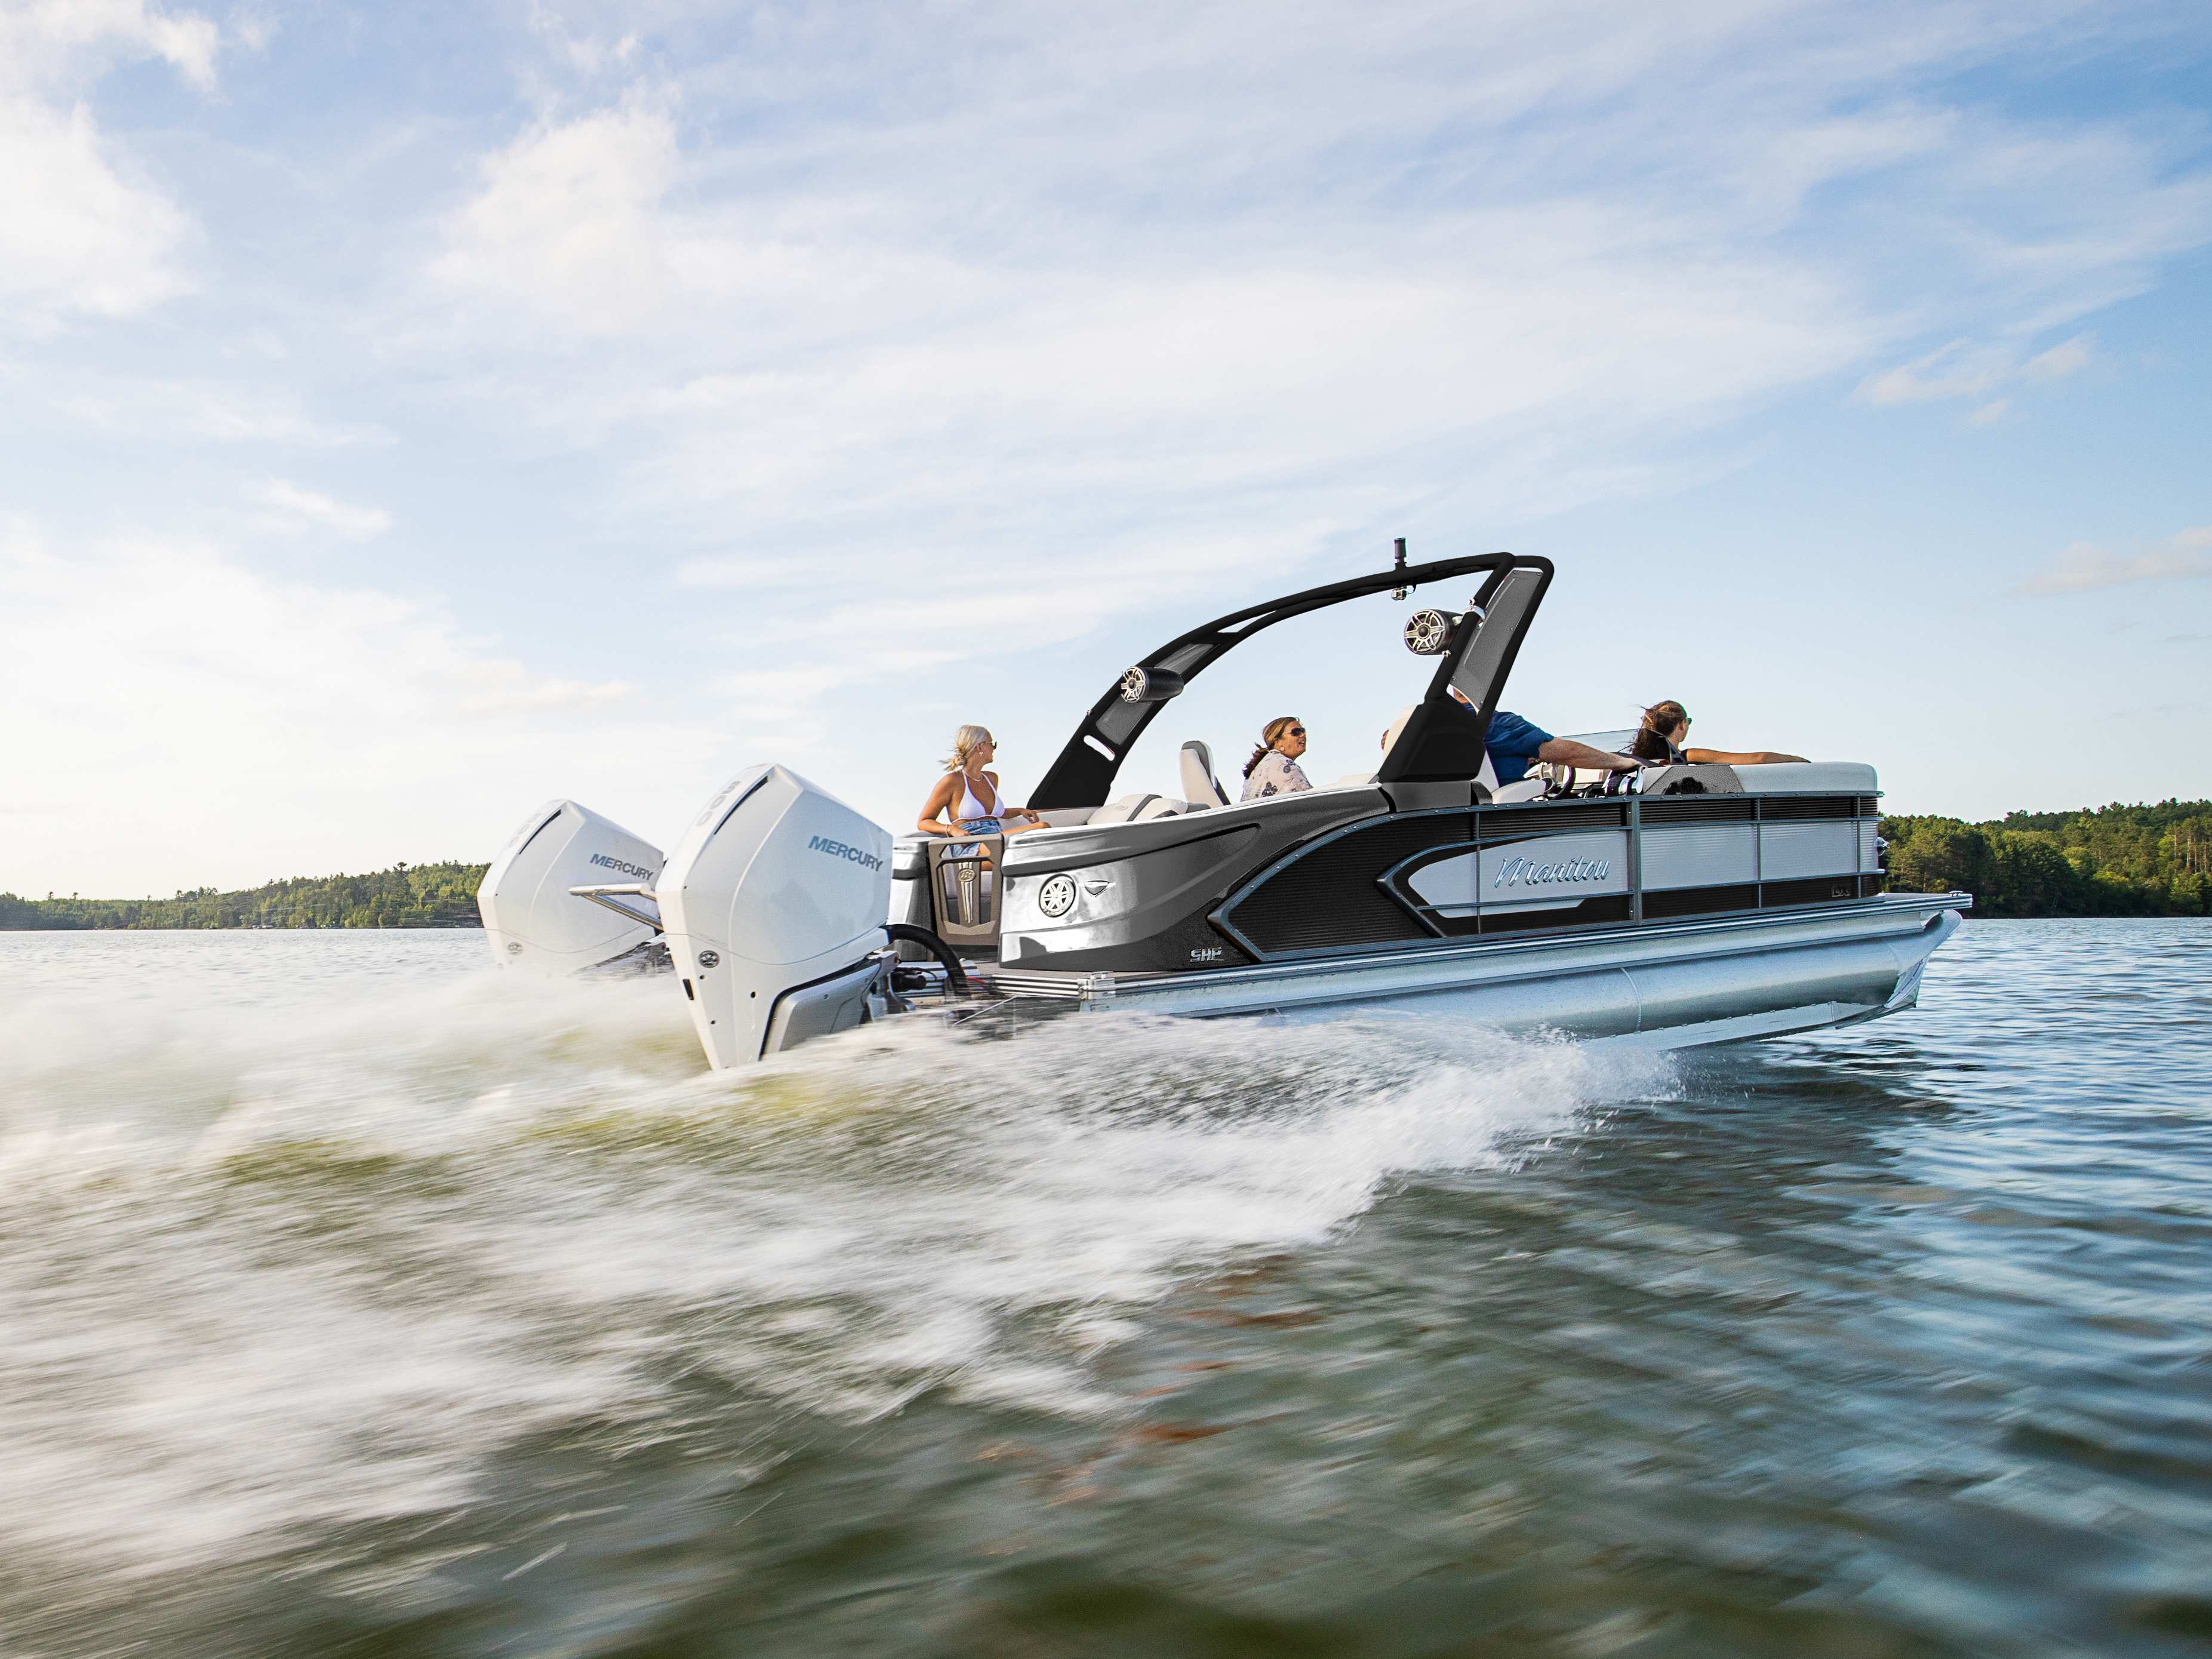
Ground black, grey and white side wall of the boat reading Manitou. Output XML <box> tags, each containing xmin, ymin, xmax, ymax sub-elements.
<box><xmin>1002</xmin><ymin>787</ymin><xmax>1882</xmax><ymax>995</ymax></box>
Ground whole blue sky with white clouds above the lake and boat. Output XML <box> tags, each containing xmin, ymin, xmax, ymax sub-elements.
<box><xmin>0</xmin><ymin>0</ymin><xmax>2212</xmax><ymax>896</ymax></box>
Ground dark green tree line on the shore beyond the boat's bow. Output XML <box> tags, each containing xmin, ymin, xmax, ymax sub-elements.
<box><xmin>1882</xmin><ymin>801</ymin><xmax>2212</xmax><ymax>916</ymax></box>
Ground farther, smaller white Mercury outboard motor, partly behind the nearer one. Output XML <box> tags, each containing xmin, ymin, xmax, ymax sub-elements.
<box><xmin>476</xmin><ymin>801</ymin><xmax>664</xmax><ymax>978</ymax></box>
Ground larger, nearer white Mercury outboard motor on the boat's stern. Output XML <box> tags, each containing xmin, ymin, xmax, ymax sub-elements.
<box><xmin>653</xmin><ymin>765</ymin><xmax>891</xmax><ymax>1070</ymax></box>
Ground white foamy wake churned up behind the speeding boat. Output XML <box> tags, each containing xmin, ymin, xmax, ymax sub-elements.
<box><xmin>0</xmin><ymin>971</ymin><xmax>1666</xmax><ymax>1581</ymax></box>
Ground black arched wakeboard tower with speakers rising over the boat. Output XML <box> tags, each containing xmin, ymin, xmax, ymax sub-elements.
<box><xmin>1029</xmin><ymin>542</ymin><xmax>1550</xmax><ymax>812</ymax></box>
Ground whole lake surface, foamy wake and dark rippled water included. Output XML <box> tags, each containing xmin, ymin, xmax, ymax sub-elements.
<box><xmin>0</xmin><ymin>922</ymin><xmax>2212</xmax><ymax>1659</ymax></box>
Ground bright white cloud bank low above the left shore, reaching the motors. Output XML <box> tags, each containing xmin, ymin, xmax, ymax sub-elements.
<box><xmin>0</xmin><ymin>524</ymin><xmax>703</xmax><ymax>894</ymax></box>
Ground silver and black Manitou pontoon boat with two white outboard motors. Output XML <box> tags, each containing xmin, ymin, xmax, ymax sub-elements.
<box><xmin>478</xmin><ymin>555</ymin><xmax>1973</xmax><ymax>1069</ymax></box>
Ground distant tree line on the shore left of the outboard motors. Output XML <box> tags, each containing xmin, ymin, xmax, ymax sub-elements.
<box><xmin>0</xmin><ymin>863</ymin><xmax>484</xmax><ymax>929</ymax></box>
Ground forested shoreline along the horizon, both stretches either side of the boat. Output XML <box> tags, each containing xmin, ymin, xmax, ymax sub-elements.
<box><xmin>0</xmin><ymin>801</ymin><xmax>2212</xmax><ymax>931</ymax></box>
